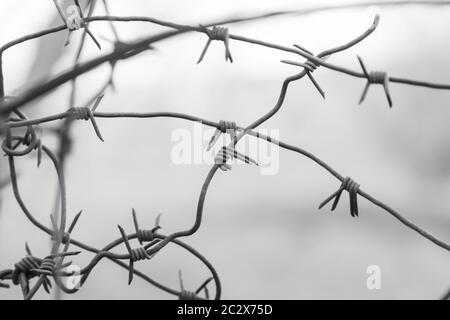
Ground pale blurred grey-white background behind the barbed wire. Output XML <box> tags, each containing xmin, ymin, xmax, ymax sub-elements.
<box><xmin>0</xmin><ymin>0</ymin><xmax>450</xmax><ymax>299</ymax></box>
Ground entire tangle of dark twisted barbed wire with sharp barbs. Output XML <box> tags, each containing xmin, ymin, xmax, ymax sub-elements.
<box><xmin>0</xmin><ymin>1</ymin><xmax>450</xmax><ymax>300</ymax></box>
